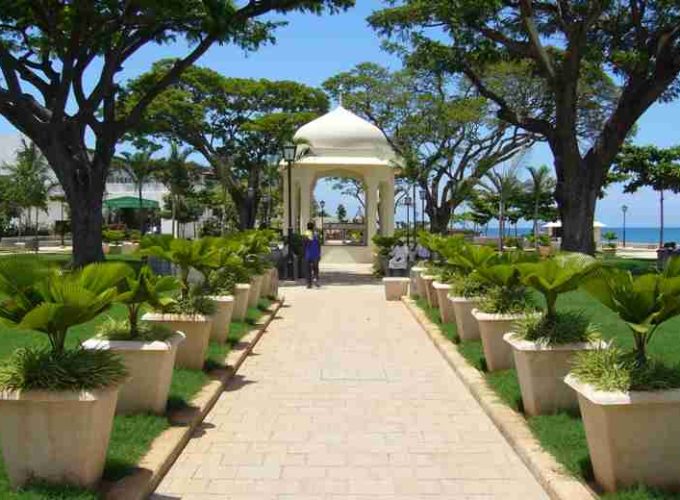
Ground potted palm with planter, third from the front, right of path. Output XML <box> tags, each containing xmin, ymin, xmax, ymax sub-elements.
<box><xmin>472</xmin><ymin>264</ymin><xmax>535</xmax><ymax>372</ymax></box>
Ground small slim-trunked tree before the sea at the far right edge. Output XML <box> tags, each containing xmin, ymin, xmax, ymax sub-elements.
<box><xmin>614</xmin><ymin>144</ymin><xmax>680</xmax><ymax>247</ymax></box>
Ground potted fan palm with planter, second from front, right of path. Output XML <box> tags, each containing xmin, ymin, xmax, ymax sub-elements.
<box><xmin>504</xmin><ymin>253</ymin><xmax>604</xmax><ymax>415</ymax></box>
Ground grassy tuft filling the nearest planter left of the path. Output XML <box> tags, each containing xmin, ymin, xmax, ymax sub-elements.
<box><xmin>0</xmin><ymin>347</ymin><xmax>127</xmax><ymax>391</ymax></box>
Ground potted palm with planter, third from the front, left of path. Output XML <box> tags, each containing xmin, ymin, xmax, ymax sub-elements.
<box><xmin>142</xmin><ymin>239</ymin><xmax>217</xmax><ymax>370</ymax></box>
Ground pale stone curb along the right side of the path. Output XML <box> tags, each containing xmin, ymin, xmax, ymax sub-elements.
<box><xmin>401</xmin><ymin>297</ymin><xmax>598</xmax><ymax>500</ymax></box>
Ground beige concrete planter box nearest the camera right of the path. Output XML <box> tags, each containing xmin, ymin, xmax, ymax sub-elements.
<box><xmin>564</xmin><ymin>375</ymin><xmax>680</xmax><ymax>492</ymax></box>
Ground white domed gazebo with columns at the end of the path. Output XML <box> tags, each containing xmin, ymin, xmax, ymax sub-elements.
<box><xmin>281</xmin><ymin>106</ymin><xmax>399</xmax><ymax>263</ymax></box>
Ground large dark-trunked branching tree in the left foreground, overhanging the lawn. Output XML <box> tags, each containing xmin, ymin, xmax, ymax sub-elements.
<box><xmin>0</xmin><ymin>0</ymin><xmax>354</xmax><ymax>265</ymax></box>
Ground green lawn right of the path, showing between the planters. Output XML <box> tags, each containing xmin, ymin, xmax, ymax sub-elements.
<box><xmin>417</xmin><ymin>274</ymin><xmax>680</xmax><ymax>500</ymax></box>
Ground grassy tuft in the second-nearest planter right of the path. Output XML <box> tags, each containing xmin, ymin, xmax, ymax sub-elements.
<box><xmin>515</xmin><ymin>311</ymin><xmax>599</xmax><ymax>345</ymax></box>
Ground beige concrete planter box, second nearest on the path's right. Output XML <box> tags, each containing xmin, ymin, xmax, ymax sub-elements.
<box><xmin>503</xmin><ymin>333</ymin><xmax>607</xmax><ymax>416</ymax></box>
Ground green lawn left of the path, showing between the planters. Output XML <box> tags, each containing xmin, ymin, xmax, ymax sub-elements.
<box><xmin>0</xmin><ymin>296</ymin><xmax>272</xmax><ymax>500</ymax></box>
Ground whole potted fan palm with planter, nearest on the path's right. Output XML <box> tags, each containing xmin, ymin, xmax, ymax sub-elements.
<box><xmin>565</xmin><ymin>258</ymin><xmax>680</xmax><ymax>491</ymax></box>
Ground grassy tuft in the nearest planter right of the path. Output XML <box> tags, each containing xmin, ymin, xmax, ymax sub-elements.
<box><xmin>571</xmin><ymin>347</ymin><xmax>680</xmax><ymax>392</ymax></box>
